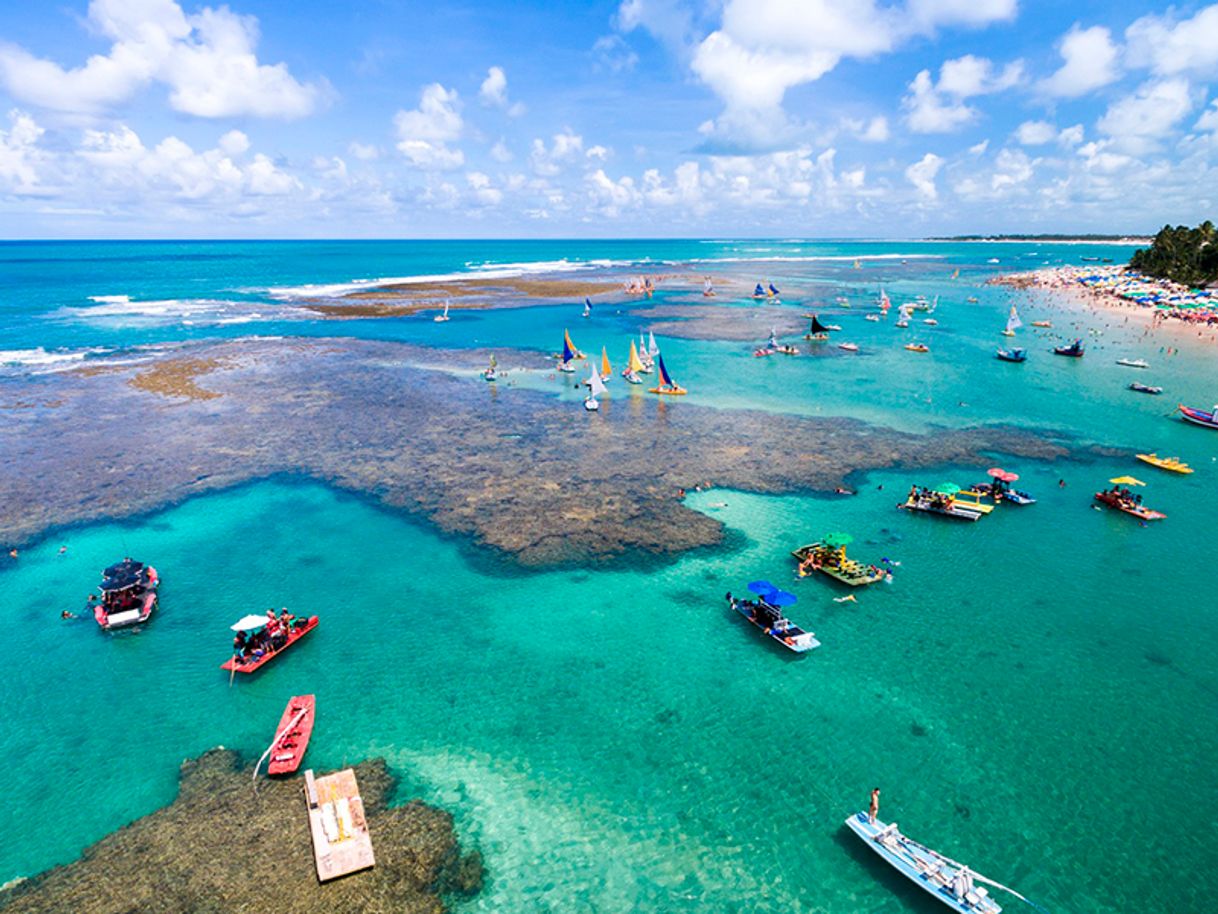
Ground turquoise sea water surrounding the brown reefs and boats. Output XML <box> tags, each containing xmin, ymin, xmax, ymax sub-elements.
<box><xmin>0</xmin><ymin>240</ymin><xmax>1218</xmax><ymax>914</ymax></box>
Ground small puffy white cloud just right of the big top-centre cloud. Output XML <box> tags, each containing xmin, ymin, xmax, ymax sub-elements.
<box><xmin>901</xmin><ymin>54</ymin><xmax>1023</xmax><ymax>133</ymax></box>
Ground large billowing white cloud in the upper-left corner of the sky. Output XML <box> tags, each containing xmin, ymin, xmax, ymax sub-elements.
<box><xmin>0</xmin><ymin>0</ymin><xmax>328</xmax><ymax>118</ymax></box>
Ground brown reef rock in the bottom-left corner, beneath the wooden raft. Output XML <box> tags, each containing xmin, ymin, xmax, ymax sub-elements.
<box><xmin>0</xmin><ymin>749</ymin><xmax>482</xmax><ymax>914</ymax></box>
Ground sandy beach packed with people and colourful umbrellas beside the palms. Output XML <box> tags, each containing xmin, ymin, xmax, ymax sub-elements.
<box><xmin>993</xmin><ymin>266</ymin><xmax>1218</xmax><ymax>327</ymax></box>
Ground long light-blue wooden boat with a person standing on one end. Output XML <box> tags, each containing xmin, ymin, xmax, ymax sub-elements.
<box><xmin>845</xmin><ymin>813</ymin><xmax>1003</xmax><ymax>914</ymax></box>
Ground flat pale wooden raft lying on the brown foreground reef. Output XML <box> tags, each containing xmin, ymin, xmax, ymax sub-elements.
<box><xmin>305</xmin><ymin>768</ymin><xmax>376</xmax><ymax>882</ymax></box>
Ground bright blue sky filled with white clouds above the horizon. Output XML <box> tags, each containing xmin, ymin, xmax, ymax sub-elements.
<box><xmin>0</xmin><ymin>0</ymin><xmax>1218</xmax><ymax>239</ymax></box>
